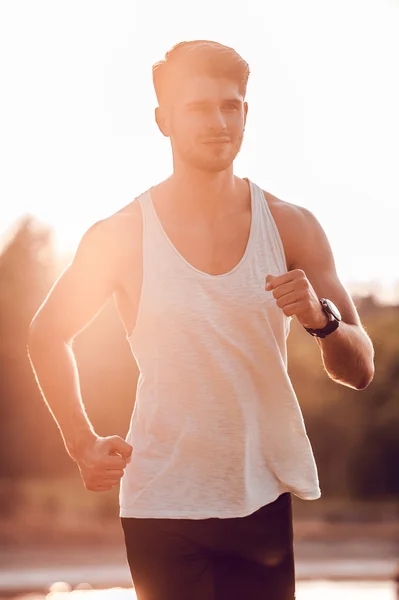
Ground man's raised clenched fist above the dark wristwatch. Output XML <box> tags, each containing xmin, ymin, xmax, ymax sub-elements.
<box><xmin>265</xmin><ymin>269</ymin><xmax>328</xmax><ymax>329</ymax></box>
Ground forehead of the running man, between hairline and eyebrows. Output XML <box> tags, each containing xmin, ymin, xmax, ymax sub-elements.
<box><xmin>176</xmin><ymin>75</ymin><xmax>243</xmax><ymax>104</ymax></box>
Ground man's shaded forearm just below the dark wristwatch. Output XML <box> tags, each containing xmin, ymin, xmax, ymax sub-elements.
<box><xmin>316</xmin><ymin>321</ymin><xmax>374</xmax><ymax>389</ymax></box>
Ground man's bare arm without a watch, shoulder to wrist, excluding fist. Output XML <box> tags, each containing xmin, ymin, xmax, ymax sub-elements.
<box><xmin>28</xmin><ymin>218</ymin><xmax>125</xmax><ymax>459</ymax></box>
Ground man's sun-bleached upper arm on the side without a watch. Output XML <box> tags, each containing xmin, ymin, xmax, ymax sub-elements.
<box><xmin>31</xmin><ymin>222</ymin><xmax>120</xmax><ymax>341</ymax></box>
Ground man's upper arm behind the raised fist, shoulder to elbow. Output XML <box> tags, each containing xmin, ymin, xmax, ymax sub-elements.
<box><xmin>294</xmin><ymin>209</ymin><xmax>361</xmax><ymax>326</ymax></box>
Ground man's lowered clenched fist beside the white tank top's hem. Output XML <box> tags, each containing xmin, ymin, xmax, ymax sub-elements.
<box><xmin>74</xmin><ymin>435</ymin><xmax>133</xmax><ymax>492</ymax></box>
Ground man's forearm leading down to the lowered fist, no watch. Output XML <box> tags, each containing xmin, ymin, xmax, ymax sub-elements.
<box><xmin>28</xmin><ymin>334</ymin><xmax>96</xmax><ymax>459</ymax></box>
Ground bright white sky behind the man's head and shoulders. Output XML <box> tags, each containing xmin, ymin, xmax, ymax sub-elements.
<box><xmin>0</xmin><ymin>0</ymin><xmax>399</xmax><ymax>297</ymax></box>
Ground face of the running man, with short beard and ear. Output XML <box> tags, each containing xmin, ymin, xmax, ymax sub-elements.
<box><xmin>157</xmin><ymin>75</ymin><xmax>248</xmax><ymax>173</ymax></box>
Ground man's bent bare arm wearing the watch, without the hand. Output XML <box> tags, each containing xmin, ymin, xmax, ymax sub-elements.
<box><xmin>290</xmin><ymin>207</ymin><xmax>374</xmax><ymax>390</ymax></box>
